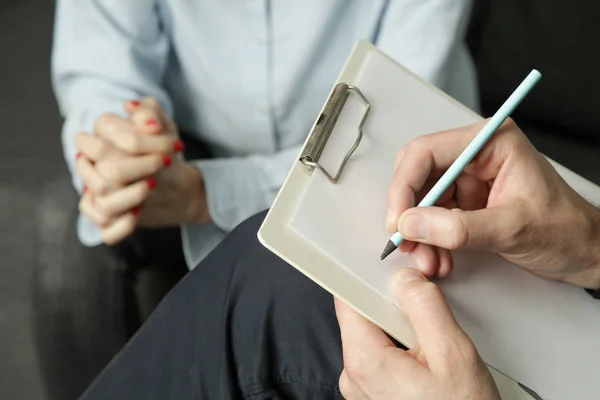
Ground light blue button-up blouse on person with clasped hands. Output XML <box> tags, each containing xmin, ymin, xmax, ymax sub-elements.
<box><xmin>52</xmin><ymin>0</ymin><xmax>477</xmax><ymax>267</ymax></box>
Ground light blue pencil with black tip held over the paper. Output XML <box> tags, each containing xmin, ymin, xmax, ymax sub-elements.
<box><xmin>381</xmin><ymin>69</ymin><xmax>542</xmax><ymax>260</ymax></box>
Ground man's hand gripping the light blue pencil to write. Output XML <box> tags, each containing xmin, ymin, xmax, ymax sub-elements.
<box><xmin>387</xmin><ymin>120</ymin><xmax>600</xmax><ymax>289</ymax></box>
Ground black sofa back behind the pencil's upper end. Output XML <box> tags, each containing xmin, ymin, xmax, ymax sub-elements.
<box><xmin>468</xmin><ymin>0</ymin><xmax>600</xmax><ymax>183</ymax></box>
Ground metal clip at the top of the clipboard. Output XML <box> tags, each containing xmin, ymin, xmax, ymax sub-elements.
<box><xmin>300</xmin><ymin>83</ymin><xmax>371</xmax><ymax>183</ymax></box>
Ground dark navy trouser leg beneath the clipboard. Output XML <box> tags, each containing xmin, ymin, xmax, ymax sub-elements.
<box><xmin>82</xmin><ymin>213</ymin><xmax>342</xmax><ymax>400</ymax></box>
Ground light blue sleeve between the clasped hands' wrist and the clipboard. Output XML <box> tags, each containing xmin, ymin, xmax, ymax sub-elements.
<box><xmin>192</xmin><ymin>146</ymin><xmax>301</xmax><ymax>231</ymax></box>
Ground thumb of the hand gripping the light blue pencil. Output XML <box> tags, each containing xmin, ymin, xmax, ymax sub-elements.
<box><xmin>398</xmin><ymin>207</ymin><xmax>515</xmax><ymax>251</ymax></box>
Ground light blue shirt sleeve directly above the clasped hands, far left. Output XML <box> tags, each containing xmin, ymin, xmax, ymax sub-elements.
<box><xmin>52</xmin><ymin>0</ymin><xmax>172</xmax><ymax>194</ymax></box>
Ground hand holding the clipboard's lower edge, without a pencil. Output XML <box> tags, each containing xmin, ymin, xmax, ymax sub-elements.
<box><xmin>335</xmin><ymin>268</ymin><xmax>500</xmax><ymax>400</ymax></box>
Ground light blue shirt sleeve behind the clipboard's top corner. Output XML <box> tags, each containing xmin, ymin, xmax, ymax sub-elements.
<box><xmin>376</xmin><ymin>0</ymin><xmax>478</xmax><ymax>109</ymax></box>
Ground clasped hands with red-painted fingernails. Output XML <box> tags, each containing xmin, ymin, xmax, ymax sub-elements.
<box><xmin>76</xmin><ymin>99</ymin><xmax>208</xmax><ymax>245</ymax></box>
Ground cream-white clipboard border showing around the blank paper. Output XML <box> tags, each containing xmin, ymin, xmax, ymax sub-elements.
<box><xmin>257</xmin><ymin>41</ymin><xmax>540</xmax><ymax>400</ymax></box>
